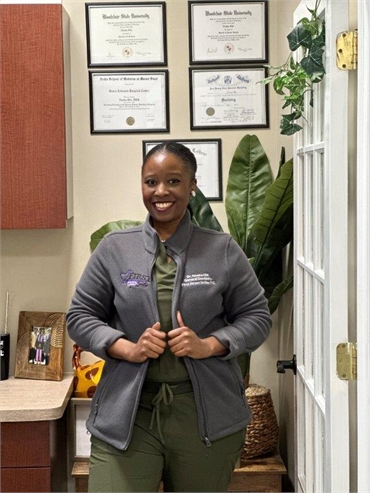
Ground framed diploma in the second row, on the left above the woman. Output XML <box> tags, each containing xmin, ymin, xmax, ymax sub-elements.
<box><xmin>89</xmin><ymin>70</ymin><xmax>169</xmax><ymax>133</ymax></box>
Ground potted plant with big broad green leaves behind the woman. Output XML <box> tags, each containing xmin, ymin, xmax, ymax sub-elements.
<box><xmin>90</xmin><ymin>135</ymin><xmax>293</xmax><ymax>385</ymax></box>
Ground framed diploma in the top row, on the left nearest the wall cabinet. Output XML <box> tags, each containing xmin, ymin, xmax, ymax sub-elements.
<box><xmin>85</xmin><ymin>2</ymin><xmax>167</xmax><ymax>67</ymax></box>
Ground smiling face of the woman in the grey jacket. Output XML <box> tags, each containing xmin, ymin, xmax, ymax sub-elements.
<box><xmin>141</xmin><ymin>152</ymin><xmax>196</xmax><ymax>233</ymax></box>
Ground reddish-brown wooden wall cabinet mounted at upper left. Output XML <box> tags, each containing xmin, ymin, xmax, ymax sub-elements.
<box><xmin>0</xmin><ymin>4</ymin><xmax>70</xmax><ymax>229</ymax></box>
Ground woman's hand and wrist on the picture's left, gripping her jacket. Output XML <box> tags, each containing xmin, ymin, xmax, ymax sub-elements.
<box><xmin>107</xmin><ymin>322</ymin><xmax>167</xmax><ymax>363</ymax></box>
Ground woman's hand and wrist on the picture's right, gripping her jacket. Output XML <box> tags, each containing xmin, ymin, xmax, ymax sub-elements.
<box><xmin>168</xmin><ymin>312</ymin><xmax>228</xmax><ymax>359</ymax></box>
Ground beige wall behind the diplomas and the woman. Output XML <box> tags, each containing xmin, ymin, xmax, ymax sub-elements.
<box><xmin>0</xmin><ymin>0</ymin><xmax>299</xmax><ymax>480</ymax></box>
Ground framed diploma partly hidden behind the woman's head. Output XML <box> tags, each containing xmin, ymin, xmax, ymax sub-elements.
<box><xmin>143</xmin><ymin>139</ymin><xmax>222</xmax><ymax>201</ymax></box>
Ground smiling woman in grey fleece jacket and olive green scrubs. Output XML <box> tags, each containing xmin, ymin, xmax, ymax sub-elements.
<box><xmin>67</xmin><ymin>141</ymin><xmax>271</xmax><ymax>492</ymax></box>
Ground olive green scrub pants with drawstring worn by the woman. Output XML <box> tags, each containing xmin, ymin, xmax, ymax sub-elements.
<box><xmin>89</xmin><ymin>384</ymin><xmax>246</xmax><ymax>492</ymax></box>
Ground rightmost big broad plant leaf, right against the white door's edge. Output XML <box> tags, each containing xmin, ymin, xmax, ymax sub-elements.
<box><xmin>247</xmin><ymin>159</ymin><xmax>293</xmax><ymax>285</ymax></box>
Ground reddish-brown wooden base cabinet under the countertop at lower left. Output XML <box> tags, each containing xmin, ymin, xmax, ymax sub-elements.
<box><xmin>1</xmin><ymin>418</ymin><xmax>67</xmax><ymax>493</ymax></box>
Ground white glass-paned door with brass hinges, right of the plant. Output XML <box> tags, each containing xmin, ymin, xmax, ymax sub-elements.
<box><xmin>294</xmin><ymin>0</ymin><xmax>349</xmax><ymax>493</ymax></box>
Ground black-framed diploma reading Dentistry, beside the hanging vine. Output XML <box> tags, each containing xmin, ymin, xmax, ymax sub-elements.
<box><xmin>189</xmin><ymin>67</ymin><xmax>269</xmax><ymax>130</ymax></box>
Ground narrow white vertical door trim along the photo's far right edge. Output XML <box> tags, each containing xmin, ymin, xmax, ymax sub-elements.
<box><xmin>356</xmin><ymin>0</ymin><xmax>370</xmax><ymax>493</ymax></box>
